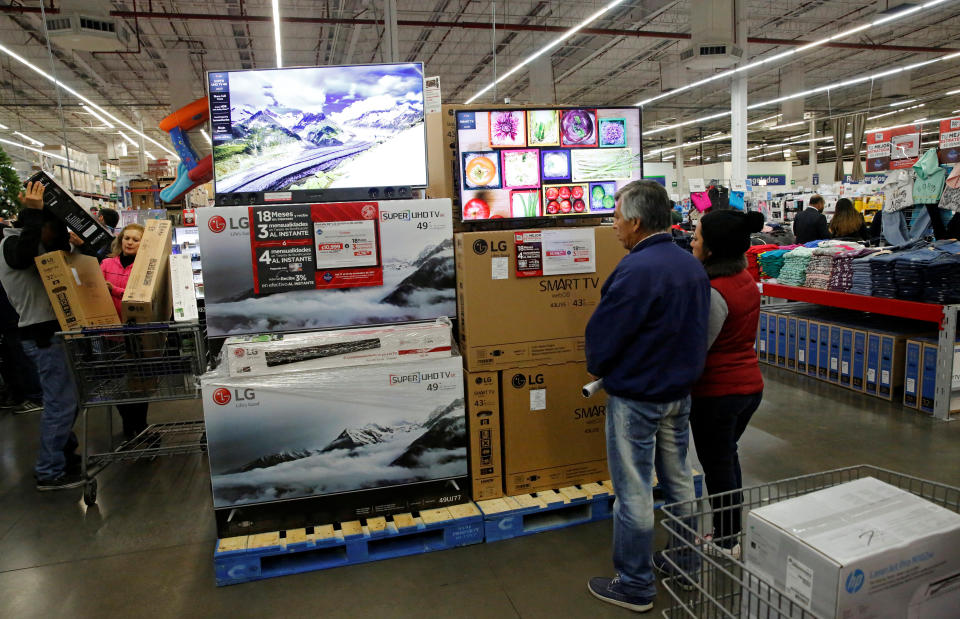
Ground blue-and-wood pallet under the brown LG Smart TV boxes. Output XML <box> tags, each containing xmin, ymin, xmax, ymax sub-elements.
<box><xmin>477</xmin><ymin>473</ymin><xmax>703</xmax><ymax>542</ymax></box>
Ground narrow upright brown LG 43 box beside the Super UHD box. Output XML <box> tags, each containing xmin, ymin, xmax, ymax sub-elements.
<box><xmin>465</xmin><ymin>372</ymin><xmax>503</xmax><ymax>501</ymax></box>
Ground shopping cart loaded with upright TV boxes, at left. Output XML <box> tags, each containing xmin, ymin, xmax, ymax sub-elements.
<box><xmin>60</xmin><ymin>323</ymin><xmax>207</xmax><ymax>505</ymax></box>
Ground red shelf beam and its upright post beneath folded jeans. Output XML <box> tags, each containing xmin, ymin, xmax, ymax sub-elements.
<box><xmin>760</xmin><ymin>283</ymin><xmax>960</xmax><ymax>421</ymax></box>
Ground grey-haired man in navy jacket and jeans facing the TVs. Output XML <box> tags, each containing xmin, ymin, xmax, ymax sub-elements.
<box><xmin>586</xmin><ymin>180</ymin><xmax>710</xmax><ymax>612</ymax></box>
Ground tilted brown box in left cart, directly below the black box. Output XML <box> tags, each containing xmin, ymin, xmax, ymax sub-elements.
<box><xmin>34</xmin><ymin>251</ymin><xmax>120</xmax><ymax>331</ymax></box>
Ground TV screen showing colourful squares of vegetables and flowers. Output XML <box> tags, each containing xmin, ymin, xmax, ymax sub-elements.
<box><xmin>457</xmin><ymin>108</ymin><xmax>642</xmax><ymax>220</ymax></box>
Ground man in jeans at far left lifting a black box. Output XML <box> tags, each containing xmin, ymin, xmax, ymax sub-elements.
<box><xmin>0</xmin><ymin>182</ymin><xmax>83</xmax><ymax>490</ymax></box>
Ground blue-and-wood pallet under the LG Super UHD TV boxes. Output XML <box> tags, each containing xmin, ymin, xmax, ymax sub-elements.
<box><xmin>213</xmin><ymin>503</ymin><xmax>483</xmax><ymax>586</ymax></box>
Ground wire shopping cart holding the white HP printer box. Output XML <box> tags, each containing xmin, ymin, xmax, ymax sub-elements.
<box><xmin>661</xmin><ymin>465</ymin><xmax>960</xmax><ymax>619</ymax></box>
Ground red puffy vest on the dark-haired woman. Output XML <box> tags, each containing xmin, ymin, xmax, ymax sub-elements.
<box><xmin>693</xmin><ymin>270</ymin><xmax>763</xmax><ymax>397</ymax></box>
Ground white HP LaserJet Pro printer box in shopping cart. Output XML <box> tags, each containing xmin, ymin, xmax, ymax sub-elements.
<box><xmin>744</xmin><ymin>477</ymin><xmax>960</xmax><ymax>619</ymax></box>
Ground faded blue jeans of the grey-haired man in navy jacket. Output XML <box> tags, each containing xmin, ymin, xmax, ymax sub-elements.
<box><xmin>607</xmin><ymin>395</ymin><xmax>696</xmax><ymax>598</ymax></box>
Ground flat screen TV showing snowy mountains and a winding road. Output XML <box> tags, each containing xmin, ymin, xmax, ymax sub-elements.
<box><xmin>208</xmin><ymin>62</ymin><xmax>427</xmax><ymax>205</ymax></box>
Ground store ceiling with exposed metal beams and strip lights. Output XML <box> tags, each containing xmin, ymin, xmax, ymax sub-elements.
<box><xmin>0</xmin><ymin>0</ymin><xmax>960</xmax><ymax>163</ymax></box>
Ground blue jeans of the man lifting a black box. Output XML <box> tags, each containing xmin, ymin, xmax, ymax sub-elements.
<box><xmin>23</xmin><ymin>337</ymin><xmax>77</xmax><ymax>479</ymax></box>
